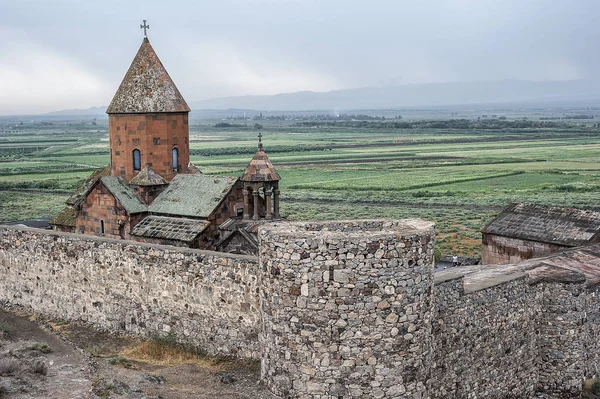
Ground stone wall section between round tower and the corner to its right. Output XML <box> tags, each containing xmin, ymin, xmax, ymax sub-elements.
<box><xmin>429</xmin><ymin>279</ymin><xmax>540</xmax><ymax>399</ymax></box>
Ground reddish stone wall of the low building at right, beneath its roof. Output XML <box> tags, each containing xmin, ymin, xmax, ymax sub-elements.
<box><xmin>481</xmin><ymin>233</ymin><xmax>571</xmax><ymax>265</ymax></box>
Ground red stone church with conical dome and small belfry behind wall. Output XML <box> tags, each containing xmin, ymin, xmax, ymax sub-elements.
<box><xmin>50</xmin><ymin>33</ymin><xmax>280</xmax><ymax>254</ymax></box>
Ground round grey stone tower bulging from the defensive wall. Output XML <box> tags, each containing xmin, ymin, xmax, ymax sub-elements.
<box><xmin>259</xmin><ymin>220</ymin><xmax>434</xmax><ymax>399</ymax></box>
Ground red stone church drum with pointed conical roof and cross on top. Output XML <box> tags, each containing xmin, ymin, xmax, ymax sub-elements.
<box><xmin>106</xmin><ymin>21</ymin><xmax>190</xmax><ymax>182</ymax></box>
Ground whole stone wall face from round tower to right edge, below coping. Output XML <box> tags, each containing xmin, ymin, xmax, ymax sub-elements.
<box><xmin>428</xmin><ymin>276</ymin><xmax>600</xmax><ymax>399</ymax></box>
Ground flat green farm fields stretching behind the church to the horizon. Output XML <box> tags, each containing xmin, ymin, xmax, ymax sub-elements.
<box><xmin>0</xmin><ymin>118</ymin><xmax>600</xmax><ymax>255</ymax></box>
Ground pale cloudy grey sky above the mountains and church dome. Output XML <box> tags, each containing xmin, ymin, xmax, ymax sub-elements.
<box><xmin>0</xmin><ymin>0</ymin><xmax>600</xmax><ymax>115</ymax></box>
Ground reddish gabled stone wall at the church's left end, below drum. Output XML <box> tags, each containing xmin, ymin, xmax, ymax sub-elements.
<box><xmin>75</xmin><ymin>183</ymin><xmax>145</xmax><ymax>239</ymax></box>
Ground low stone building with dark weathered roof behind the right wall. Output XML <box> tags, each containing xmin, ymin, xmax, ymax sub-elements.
<box><xmin>481</xmin><ymin>203</ymin><xmax>600</xmax><ymax>264</ymax></box>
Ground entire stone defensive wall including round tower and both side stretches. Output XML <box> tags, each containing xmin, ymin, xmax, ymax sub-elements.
<box><xmin>0</xmin><ymin>220</ymin><xmax>600</xmax><ymax>399</ymax></box>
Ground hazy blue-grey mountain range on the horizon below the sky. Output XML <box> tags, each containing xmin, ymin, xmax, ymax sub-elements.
<box><xmin>47</xmin><ymin>80</ymin><xmax>600</xmax><ymax>115</ymax></box>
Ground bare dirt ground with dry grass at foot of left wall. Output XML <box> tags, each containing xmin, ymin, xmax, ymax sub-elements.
<box><xmin>0</xmin><ymin>308</ymin><xmax>276</xmax><ymax>399</ymax></box>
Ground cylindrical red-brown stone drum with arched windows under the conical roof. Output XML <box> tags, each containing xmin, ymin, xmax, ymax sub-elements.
<box><xmin>108</xmin><ymin>112</ymin><xmax>190</xmax><ymax>182</ymax></box>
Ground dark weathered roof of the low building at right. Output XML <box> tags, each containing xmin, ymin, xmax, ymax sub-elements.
<box><xmin>481</xmin><ymin>203</ymin><xmax>600</xmax><ymax>246</ymax></box>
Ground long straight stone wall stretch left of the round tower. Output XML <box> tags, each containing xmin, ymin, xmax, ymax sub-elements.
<box><xmin>0</xmin><ymin>227</ymin><xmax>260</xmax><ymax>358</ymax></box>
